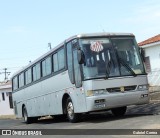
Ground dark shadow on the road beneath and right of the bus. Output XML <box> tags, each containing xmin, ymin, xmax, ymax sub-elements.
<box><xmin>33</xmin><ymin>103</ymin><xmax>160</xmax><ymax>124</ymax></box>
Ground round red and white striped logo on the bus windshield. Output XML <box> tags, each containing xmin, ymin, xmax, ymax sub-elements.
<box><xmin>90</xmin><ymin>41</ymin><xmax>103</xmax><ymax>52</ymax></box>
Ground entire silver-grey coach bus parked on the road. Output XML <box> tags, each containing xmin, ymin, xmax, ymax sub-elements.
<box><xmin>12</xmin><ymin>33</ymin><xmax>149</xmax><ymax>123</ymax></box>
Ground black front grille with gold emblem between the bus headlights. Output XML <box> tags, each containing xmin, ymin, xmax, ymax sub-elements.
<box><xmin>106</xmin><ymin>85</ymin><xmax>137</xmax><ymax>92</ymax></box>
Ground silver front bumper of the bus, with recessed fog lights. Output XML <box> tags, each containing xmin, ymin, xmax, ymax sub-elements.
<box><xmin>86</xmin><ymin>90</ymin><xmax>149</xmax><ymax>112</ymax></box>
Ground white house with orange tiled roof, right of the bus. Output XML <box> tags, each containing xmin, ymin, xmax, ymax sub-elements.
<box><xmin>138</xmin><ymin>34</ymin><xmax>160</xmax><ymax>87</ymax></box>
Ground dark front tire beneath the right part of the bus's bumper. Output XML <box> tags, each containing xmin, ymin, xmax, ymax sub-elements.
<box><xmin>111</xmin><ymin>106</ymin><xmax>127</xmax><ymax>117</ymax></box>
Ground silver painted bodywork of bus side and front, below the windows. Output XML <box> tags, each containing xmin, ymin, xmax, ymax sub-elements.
<box><xmin>13</xmin><ymin>71</ymin><xmax>149</xmax><ymax>117</ymax></box>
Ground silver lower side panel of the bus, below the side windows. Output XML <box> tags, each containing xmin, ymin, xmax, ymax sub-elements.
<box><xmin>14</xmin><ymin>71</ymin><xmax>87</xmax><ymax>117</ymax></box>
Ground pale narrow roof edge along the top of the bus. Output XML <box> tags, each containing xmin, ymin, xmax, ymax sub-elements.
<box><xmin>12</xmin><ymin>32</ymin><xmax>134</xmax><ymax>78</ymax></box>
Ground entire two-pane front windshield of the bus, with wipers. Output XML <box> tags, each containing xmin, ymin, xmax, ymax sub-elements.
<box><xmin>80</xmin><ymin>37</ymin><xmax>145</xmax><ymax>80</ymax></box>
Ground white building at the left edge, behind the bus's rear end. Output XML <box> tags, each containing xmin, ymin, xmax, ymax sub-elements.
<box><xmin>0</xmin><ymin>81</ymin><xmax>14</xmax><ymax>116</ymax></box>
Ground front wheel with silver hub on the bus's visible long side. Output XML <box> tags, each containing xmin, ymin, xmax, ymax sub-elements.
<box><xmin>66</xmin><ymin>97</ymin><xmax>81</xmax><ymax>123</ymax></box>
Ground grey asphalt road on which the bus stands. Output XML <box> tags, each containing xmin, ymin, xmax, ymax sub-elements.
<box><xmin>0</xmin><ymin>103</ymin><xmax>160</xmax><ymax>138</ymax></box>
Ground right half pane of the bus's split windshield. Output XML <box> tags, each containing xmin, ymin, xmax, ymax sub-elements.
<box><xmin>112</xmin><ymin>37</ymin><xmax>145</xmax><ymax>75</ymax></box>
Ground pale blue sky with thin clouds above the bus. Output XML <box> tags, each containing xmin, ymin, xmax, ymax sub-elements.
<box><xmin>0</xmin><ymin>0</ymin><xmax>160</xmax><ymax>82</ymax></box>
